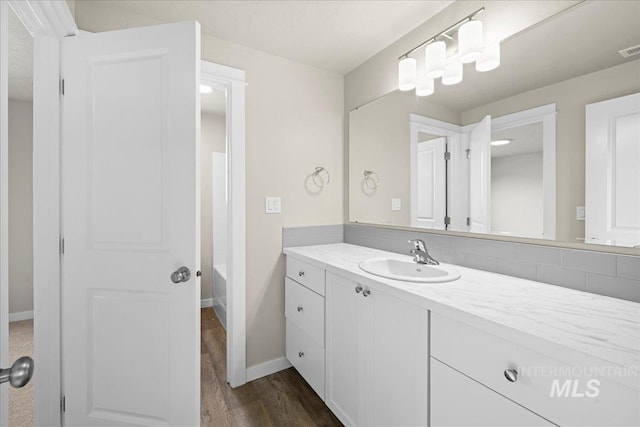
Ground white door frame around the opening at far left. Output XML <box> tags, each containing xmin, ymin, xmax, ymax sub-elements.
<box><xmin>0</xmin><ymin>0</ymin><xmax>78</xmax><ymax>426</ymax></box>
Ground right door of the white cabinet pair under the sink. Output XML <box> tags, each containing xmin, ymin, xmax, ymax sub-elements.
<box><xmin>368</xmin><ymin>289</ymin><xmax>429</xmax><ymax>426</ymax></box>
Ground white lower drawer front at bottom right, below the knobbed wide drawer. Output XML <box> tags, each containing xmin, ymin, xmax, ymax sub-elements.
<box><xmin>430</xmin><ymin>358</ymin><xmax>555</xmax><ymax>427</ymax></box>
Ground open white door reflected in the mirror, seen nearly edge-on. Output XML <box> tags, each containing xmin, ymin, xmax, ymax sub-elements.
<box><xmin>469</xmin><ymin>116</ymin><xmax>491</xmax><ymax>233</ymax></box>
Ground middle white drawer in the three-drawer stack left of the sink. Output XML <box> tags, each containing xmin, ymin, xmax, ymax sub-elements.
<box><xmin>284</xmin><ymin>277</ymin><xmax>324</xmax><ymax>348</ymax></box>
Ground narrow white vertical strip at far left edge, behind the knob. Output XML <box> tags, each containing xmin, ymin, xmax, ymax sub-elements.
<box><xmin>0</xmin><ymin>1</ymin><xmax>9</xmax><ymax>426</ymax></box>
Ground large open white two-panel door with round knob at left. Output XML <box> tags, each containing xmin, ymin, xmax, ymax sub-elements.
<box><xmin>61</xmin><ymin>22</ymin><xmax>200</xmax><ymax>426</ymax></box>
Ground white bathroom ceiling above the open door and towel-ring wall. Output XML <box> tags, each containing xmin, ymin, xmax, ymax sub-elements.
<box><xmin>75</xmin><ymin>0</ymin><xmax>453</xmax><ymax>75</ymax></box>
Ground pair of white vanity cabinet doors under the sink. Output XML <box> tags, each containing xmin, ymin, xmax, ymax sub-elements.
<box><xmin>325</xmin><ymin>273</ymin><xmax>429</xmax><ymax>426</ymax></box>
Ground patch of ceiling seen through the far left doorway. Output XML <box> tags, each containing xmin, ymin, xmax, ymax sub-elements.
<box><xmin>8</xmin><ymin>8</ymin><xmax>33</xmax><ymax>100</ymax></box>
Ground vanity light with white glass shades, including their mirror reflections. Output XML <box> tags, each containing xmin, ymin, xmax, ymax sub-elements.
<box><xmin>398</xmin><ymin>7</ymin><xmax>500</xmax><ymax>96</ymax></box>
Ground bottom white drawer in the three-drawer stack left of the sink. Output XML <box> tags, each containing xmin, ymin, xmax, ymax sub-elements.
<box><xmin>286</xmin><ymin>319</ymin><xmax>324</xmax><ymax>400</ymax></box>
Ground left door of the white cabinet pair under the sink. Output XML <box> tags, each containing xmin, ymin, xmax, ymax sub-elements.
<box><xmin>325</xmin><ymin>273</ymin><xmax>364</xmax><ymax>426</ymax></box>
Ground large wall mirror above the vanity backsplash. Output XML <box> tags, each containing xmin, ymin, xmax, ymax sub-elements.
<box><xmin>349</xmin><ymin>1</ymin><xmax>640</xmax><ymax>247</ymax></box>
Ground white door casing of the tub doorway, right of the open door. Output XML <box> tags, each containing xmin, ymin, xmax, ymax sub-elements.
<box><xmin>201</xmin><ymin>61</ymin><xmax>248</xmax><ymax>387</ymax></box>
